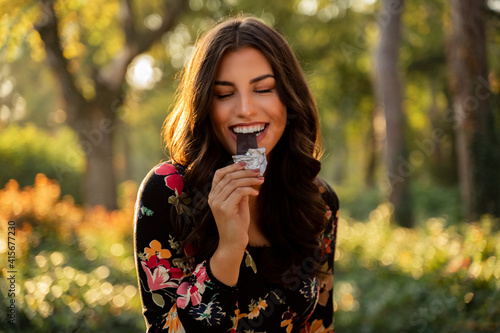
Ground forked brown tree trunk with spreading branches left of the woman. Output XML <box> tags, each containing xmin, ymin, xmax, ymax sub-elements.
<box><xmin>35</xmin><ymin>0</ymin><xmax>187</xmax><ymax>210</ymax></box>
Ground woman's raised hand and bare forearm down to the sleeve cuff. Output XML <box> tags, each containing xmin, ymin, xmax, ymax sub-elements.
<box><xmin>208</xmin><ymin>162</ymin><xmax>264</xmax><ymax>286</ymax></box>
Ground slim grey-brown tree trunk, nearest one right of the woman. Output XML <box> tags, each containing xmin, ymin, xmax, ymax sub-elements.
<box><xmin>375</xmin><ymin>0</ymin><xmax>414</xmax><ymax>227</ymax></box>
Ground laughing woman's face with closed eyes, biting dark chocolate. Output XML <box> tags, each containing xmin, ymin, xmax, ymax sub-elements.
<box><xmin>210</xmin><ymin>47</ymin><xmax>287</xmax><ymax>155</ymax></box>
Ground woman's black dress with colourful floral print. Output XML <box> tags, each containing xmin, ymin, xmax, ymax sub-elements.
<box><xmin>135</xmin><ymin>163</ymin><xmax>339</xmax><ymax>333</ymax></box>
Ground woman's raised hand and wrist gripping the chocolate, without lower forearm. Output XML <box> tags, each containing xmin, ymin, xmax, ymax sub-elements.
<box><xmin>208</xmin><ymin>162</ymin><xmax>264</xmax><ymax>250</ymax></box>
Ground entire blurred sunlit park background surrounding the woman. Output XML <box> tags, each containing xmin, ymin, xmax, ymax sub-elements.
<box><xmin>0</xmin><ymin>0</ymin><xmax>500</xmax><ymax>332</ymax></box>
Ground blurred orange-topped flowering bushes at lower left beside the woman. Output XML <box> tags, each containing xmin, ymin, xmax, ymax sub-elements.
<box><xmin>0</xmin><ymin>174</ymin><xmax>144</xmax><ymax>333</ymax></box>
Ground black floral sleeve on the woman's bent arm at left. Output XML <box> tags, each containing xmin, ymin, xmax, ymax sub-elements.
<box><xmin>134</xmin><ymin>163</ymin><xmax>237</xmax><ymax>333</ymax></box>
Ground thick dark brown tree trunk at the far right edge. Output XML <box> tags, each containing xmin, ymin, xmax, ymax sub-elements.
<box><xmin>448</xmin><ymin>0</ymin><xmax>500</xmax><ymax>220</ymax></box>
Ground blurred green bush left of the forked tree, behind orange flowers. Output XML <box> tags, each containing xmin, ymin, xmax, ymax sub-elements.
<box><xmin>0</xmin><ymin>124</ymin><xmax>85</xmax><ymax>203</ymax></box>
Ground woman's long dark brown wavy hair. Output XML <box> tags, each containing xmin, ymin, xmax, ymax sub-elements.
<box><xmin>163</xmin><ymin>16</ymin><xmax>326</xmax><ymax>284</ymax></box>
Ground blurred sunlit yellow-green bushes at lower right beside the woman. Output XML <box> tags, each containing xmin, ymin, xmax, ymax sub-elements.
<box><xmin>334</xmin><ymin>205</ymin><xmax>500</xmax><ymax>332</ymax></box>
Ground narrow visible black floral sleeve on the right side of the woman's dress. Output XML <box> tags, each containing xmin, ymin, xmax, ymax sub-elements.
<box><xmin>301</xmin><ymin>181</ymin><xmax>339</xmax><ymax>333</ymax></box>
